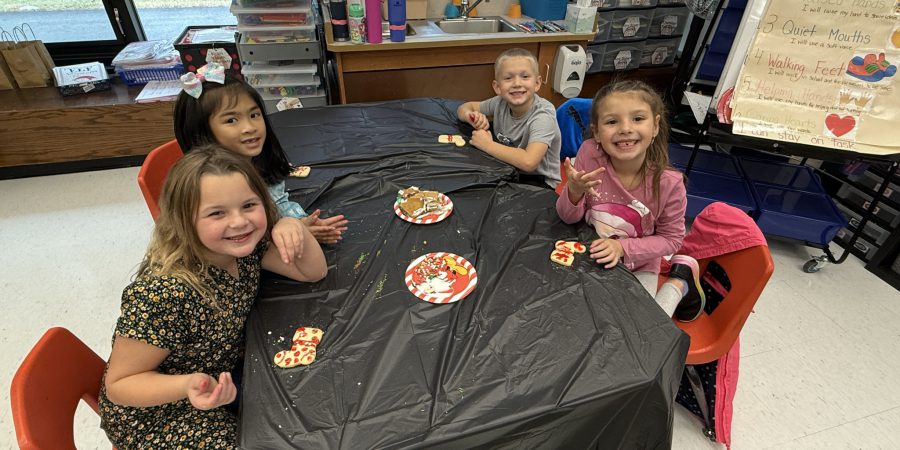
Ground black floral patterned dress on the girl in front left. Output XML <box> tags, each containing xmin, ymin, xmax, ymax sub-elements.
<box><xmin>100</xmin><ymin>242</ymin><xmax>266</xmax><ymax>450</ymax></box>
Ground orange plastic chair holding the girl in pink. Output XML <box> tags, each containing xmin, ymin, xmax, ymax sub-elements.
<box><xmin>675</xmin><ymin>245</ymin><xmax>775</xmax><ymax>364</ymax></box>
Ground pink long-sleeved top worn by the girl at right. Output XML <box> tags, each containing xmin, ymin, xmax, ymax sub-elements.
<box><xmin>556</xmin><ymin>139</ymin><xmax>687</xmax><ymax>273</ymax></box>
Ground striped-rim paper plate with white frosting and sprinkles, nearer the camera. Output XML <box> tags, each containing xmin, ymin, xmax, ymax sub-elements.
<box><xmin>405</xmin><ymin>252</ymin><xmax>478</xmax><ymax>303</ymax></box>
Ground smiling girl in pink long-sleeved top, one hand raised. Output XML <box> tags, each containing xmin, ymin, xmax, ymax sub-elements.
<box><xmin>556</xmin><ymin>80</ymin><xmax>706</xmax><ymax>321</ymax></box>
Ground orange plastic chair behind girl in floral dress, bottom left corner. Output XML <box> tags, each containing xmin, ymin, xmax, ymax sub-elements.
<box><xmin>9</xmin><ymin>327</ymin><xmax>112</xmax><ymax>450</ymax></box>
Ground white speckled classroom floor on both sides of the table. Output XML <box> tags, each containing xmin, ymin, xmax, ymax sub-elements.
<box><xmin>0</xmin><ymin>168</ymin><xmax>900</xmax><ymax>450</ymax></box>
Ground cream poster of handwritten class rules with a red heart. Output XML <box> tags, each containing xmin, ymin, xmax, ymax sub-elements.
<box><xmin>731</xmin><ymin>0</ymin><xmax>900</xmax><ymax>155</ymax></box>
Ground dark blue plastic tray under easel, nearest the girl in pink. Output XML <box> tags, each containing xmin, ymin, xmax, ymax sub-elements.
<box><xmin>675</xmin><ymin>164</ymin><xmax>758</xmax><ymax>217</ymax></box>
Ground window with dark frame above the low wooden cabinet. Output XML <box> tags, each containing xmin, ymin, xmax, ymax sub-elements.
<box><xmin>0</xmin><ymin>0</ymin><xmax>237</xmax><ymax>65</ymax></box>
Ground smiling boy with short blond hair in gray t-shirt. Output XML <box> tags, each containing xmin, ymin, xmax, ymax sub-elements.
<box><xmin>456</xmin><ymin>48</ymin><xmax>562</xmax><ymax>188</ymax></box>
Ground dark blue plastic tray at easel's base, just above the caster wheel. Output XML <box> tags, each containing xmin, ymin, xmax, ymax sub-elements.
<box><xmin>753</xmin><ymin>183</ymin><xmax>847</xmax><ymax>246</ymax></box>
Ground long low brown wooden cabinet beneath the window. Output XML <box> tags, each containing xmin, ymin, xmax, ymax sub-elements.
<box><xmin>0</xmin><ymin>80</ymin><xmax>174</xmax><ymax>178</ymax></box>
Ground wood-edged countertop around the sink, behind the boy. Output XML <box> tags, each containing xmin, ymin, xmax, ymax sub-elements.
<box><xmin>323</xmin><ymin>14</ymin><xmax>594</xmax><ymax>53</ymax></box>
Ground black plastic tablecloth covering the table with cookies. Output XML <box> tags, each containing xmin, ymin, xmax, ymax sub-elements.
<box><xmin>239</xmin><ymin>99</ymin><xmax>688</xmax><ymax>449</ymax></box>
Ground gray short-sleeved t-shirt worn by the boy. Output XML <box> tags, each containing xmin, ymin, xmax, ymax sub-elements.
<box><xmin>480</xmin><ymin>94</ymin><xmax>562</xmax><ymax>189</ymax></box>
